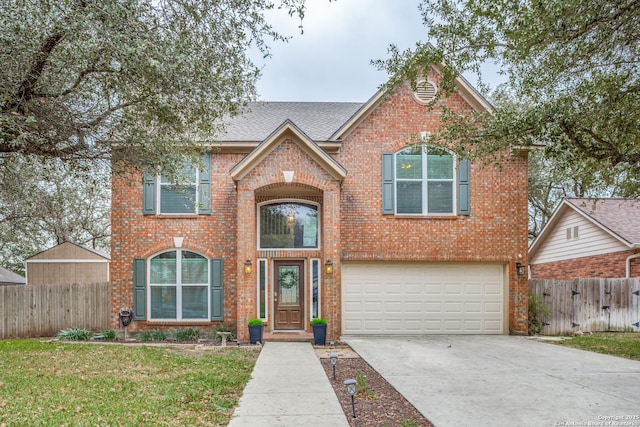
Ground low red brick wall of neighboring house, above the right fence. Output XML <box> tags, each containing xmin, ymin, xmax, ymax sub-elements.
<box><xmin>530</xmin><ymin>250</ymin><xmax>640</xmax><ymax>280</ymax></box>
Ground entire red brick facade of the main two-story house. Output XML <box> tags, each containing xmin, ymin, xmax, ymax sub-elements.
<box><xmin>111</xmin><ymin>76</ymin><xmax>527</xmax><ymax>340</ymax></box>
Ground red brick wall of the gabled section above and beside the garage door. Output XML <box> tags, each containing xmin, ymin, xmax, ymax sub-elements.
<box><xmin>337</xmin><ymin>80</ymin><xmax>528</xmax><ymax>333</ymax></box>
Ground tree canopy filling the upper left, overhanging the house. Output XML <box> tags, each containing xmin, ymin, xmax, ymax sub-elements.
<box><xmin>0</xmin><ymin>0</ymin><xmax>304</xmax><ymax>174</ymax></box>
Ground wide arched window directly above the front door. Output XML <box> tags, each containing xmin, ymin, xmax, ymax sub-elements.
<box><xmin>258</xmin><ymin>202</ymin><xmax>319</xmax><ymax>249</ymax></box>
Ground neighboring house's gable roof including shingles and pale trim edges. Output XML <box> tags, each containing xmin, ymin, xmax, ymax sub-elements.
<box><xmin>529</xmin><ymin>198</ymin><xmax>640</xmax><ymax>261</ymax></box>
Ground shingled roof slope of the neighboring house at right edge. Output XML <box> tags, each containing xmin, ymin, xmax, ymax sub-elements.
<box><xmin>567</xmin><ymin>199</ymin><xmax>640</xmax><ymax>244</ymax></box>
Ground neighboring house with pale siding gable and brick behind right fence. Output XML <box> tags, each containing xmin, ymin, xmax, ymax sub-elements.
<box><xmin>529</xmin><ymin>198</ymin><xmax>640</xmax><ymax>280</ymax></box>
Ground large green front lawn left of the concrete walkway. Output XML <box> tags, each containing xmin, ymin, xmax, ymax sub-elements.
<box><xmin>0</xmin><ymin>340</ymin><xmax>259</xmax><ymax>426</ymax></box>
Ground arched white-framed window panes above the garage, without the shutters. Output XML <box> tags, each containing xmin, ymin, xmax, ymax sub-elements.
<box><xmin>394</xmin><ymin>145</ymin><xmax>456</xmax><ymax>215</ymax></box>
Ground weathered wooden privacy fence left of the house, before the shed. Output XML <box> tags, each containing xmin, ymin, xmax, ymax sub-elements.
<box><xmin>0</xmin><ymin>282</ymin><xmax>110</xmax><ymax>339</ymax></box>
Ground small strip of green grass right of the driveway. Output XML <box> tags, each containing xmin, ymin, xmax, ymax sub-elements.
<box><xmin>554</xmin><ymin>332</ymin><xmax>640</xmax><ymax>360</ymax></box>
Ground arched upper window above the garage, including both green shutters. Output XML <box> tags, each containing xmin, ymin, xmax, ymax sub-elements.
<box><xmin>382</xmin><ymin>145</ymin><xmax>469</xmax><ymax>215</ymax></box>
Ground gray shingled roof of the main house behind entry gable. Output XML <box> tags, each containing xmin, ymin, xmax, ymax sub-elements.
<box><xmin>220</xmin><ymin>102</ymin><xmax>364</xmax><ymax>142</ymax></box>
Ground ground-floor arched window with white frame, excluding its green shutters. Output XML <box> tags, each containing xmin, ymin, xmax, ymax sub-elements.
<box><xmin>148</xmin><ymin>249</ymin><xmax>210</xmax><ymax>320</ymax></box>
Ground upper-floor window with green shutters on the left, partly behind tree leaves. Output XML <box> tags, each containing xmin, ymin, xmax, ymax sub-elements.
<box><xmin>143</xmin><ymin>154</ymin><xmax>211</xmax><ymax>215</ymax></box>
